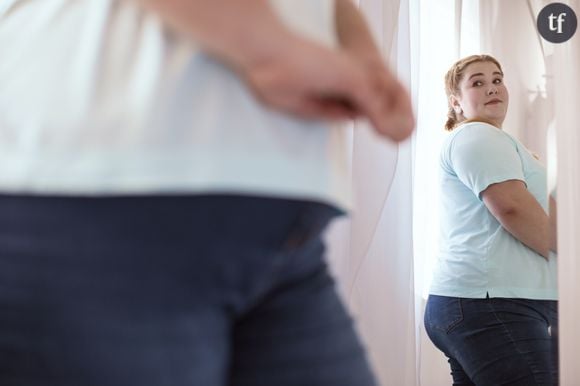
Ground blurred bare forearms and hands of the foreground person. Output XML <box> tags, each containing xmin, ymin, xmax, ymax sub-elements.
<box><xmin>133</xmin><ymin>0</ymin><xmax>415</xmax><ymax>141</ymax></box>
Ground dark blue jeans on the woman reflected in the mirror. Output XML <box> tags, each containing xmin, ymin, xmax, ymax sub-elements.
<box><xmin>425</xmin><ymin>295</ymin><xmax>558</xmax><ymax>386</ymax></box>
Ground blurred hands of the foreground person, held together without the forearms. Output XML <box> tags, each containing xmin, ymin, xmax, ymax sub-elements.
<box><xmin>240</xmin><ymin>37</ymin><xmax>415</xmax><ymax>142</ymax></box>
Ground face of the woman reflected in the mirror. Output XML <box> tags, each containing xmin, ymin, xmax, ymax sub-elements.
<box><xmin>450</xmin><ymin>62</ymin><xmax>509</xmax><ymax>128</ymax></box>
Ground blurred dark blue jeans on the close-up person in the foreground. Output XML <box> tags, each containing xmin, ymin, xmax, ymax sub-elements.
<box><xmin>0</xmin><ymin>196</ymin><xmax>375</xmax><ymax>386</ymax></box>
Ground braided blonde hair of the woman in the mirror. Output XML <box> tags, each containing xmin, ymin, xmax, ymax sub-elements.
<box><xmin>445</xmin><ymin>55</ymin><xmax>503</xmax><ymax>131</ymax></box>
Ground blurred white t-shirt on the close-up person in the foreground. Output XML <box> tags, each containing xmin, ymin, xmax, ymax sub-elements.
<box><xmin>0</xmin><ymin>0</ymin><xmax>350</xmax><ymax>208</ymax></box>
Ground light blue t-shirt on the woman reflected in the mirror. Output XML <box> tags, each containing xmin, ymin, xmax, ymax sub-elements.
<box><xmin>430</xmin><ymin>122</ymin><xmax>557</xmax><ymax>300</ymax></box>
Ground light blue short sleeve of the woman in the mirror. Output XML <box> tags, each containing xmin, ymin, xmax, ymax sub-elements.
<box><xmin>448</xmin><ymin>123</ymin><xmax>525</xmax><ymax>198</ymax></box>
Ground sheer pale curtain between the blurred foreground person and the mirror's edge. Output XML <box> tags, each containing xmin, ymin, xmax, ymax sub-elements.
<box><xmin>329</xmin><ymin>0</ymin><xmax>417</xmax><ymax>385</ymax></box>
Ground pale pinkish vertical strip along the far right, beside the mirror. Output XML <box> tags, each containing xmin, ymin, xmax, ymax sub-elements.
<box><xmin>552</xmin><ymin>0</ymin><xmax>580</xmax><ymax>386</ymax></box>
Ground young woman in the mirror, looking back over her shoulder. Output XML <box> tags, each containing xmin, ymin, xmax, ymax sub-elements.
<box><xmin>425</xmin><ymin>55</ymin><xmax>558</xmax><ymax>386</ymax></box>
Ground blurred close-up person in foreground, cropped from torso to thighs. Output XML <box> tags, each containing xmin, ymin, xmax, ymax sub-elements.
<box><xmin>0</xmin><ymin>0</ymin><xmax>414</xmax><ymax>386</ymax></box>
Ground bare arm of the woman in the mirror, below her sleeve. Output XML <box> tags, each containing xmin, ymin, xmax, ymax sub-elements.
<box><xmin>481</xmin><ymin>180</ymin><xmax>551</xmax><ymax>259</ymax></box>
